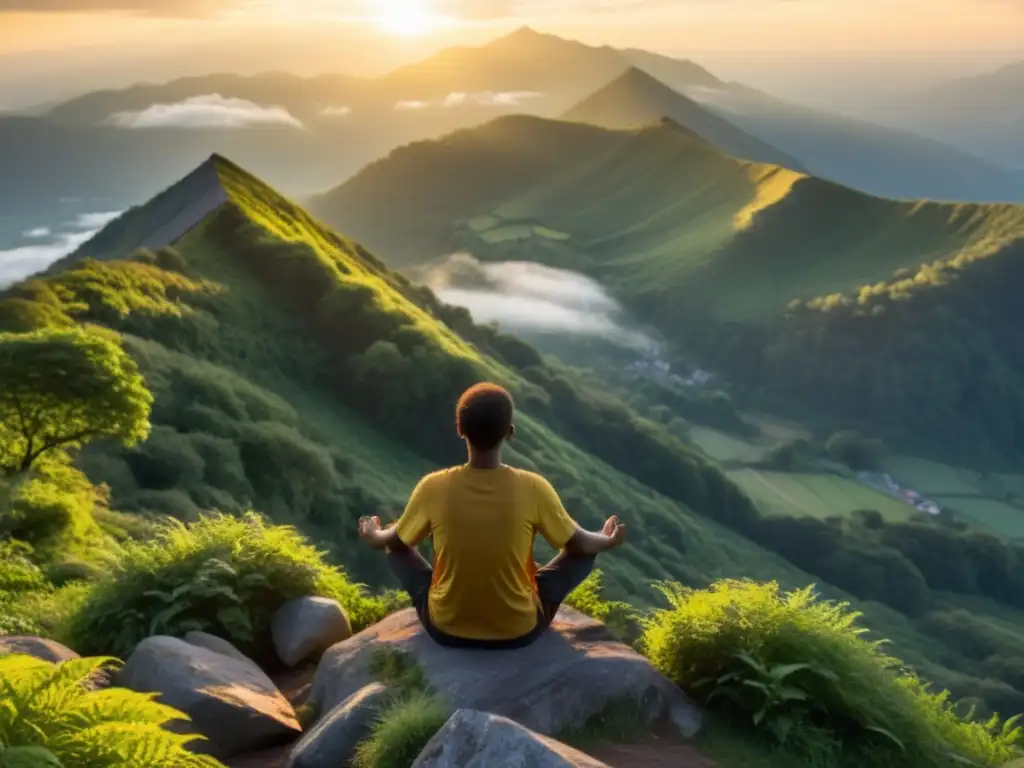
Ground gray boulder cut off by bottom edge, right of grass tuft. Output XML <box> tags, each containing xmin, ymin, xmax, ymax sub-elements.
<box><xmin>412</xmin><ymin>710</ymin><xmax>609</xmax><ymax>768</ymax></box>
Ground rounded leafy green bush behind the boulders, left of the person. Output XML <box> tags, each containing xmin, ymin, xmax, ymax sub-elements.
<box><xmin>69</xmin><ymin>513</ymin><xmax>395</xmax><ymax>658</ymax></box>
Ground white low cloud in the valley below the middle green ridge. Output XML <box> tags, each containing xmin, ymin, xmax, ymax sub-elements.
<box><xmin>426</xmin><ymin>253</ymin><xmax>654</xmax><ymax>349</ymax></box>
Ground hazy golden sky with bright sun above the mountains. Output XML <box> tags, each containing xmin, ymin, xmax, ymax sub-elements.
<box><xmin>0</xmin><ymin>0</ymin><xmax>1024</xmax><ymax>112</ymax></box>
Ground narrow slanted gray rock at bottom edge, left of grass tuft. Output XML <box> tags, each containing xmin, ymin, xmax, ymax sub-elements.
<box><xmin>286</xmin><ymin>683</ymin><xmax>388</xmax><ymax>768</ymax></box>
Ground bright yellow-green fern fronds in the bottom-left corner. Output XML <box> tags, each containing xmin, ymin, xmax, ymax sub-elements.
<box><xmin>0</xmin><ymin>654</ymin><xmax>221</xmax><ymax>768</ymax></box>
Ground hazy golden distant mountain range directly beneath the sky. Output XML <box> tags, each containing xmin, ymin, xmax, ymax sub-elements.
<box><xmin>0</xmin><ymin>29</ymin><xmax>1024</xmax><ymax>234</ymax></box>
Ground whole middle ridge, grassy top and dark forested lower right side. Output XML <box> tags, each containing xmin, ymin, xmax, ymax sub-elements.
<box><xmin>313</xmin><ymin>118</ymin><xmax>1024</xmax><ymax>461</ymax></box>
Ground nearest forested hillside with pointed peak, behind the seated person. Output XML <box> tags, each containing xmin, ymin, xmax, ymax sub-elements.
<box><xmin>6</xmin><ymin>154</ymin><xmax>1024</xmax><ymax>733</ymax></box>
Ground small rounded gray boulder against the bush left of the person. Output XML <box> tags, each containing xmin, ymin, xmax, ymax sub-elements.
<box><xmin>270</xmin><ymin>597</ymin><xmax>352</xmax><ymax>667</ymax></box>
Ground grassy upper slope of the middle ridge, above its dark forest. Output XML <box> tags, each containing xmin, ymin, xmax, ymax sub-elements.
<box><xmin>313</xmin><ymin>118</ymin><xmax>1024</xmax><ymax>321</ymax></box>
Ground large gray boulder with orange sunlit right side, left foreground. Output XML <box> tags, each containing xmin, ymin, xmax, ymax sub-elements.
<box><xmin>116</xmin><ymin>636</ymin><xmax>302</xmax><ymax>759</ymax></box>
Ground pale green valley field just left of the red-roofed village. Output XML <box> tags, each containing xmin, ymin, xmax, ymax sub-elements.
<box><xmin>727</xmin><ymin>469</ymin><xmax>915</xmax><ymax>520</ymax></box>
